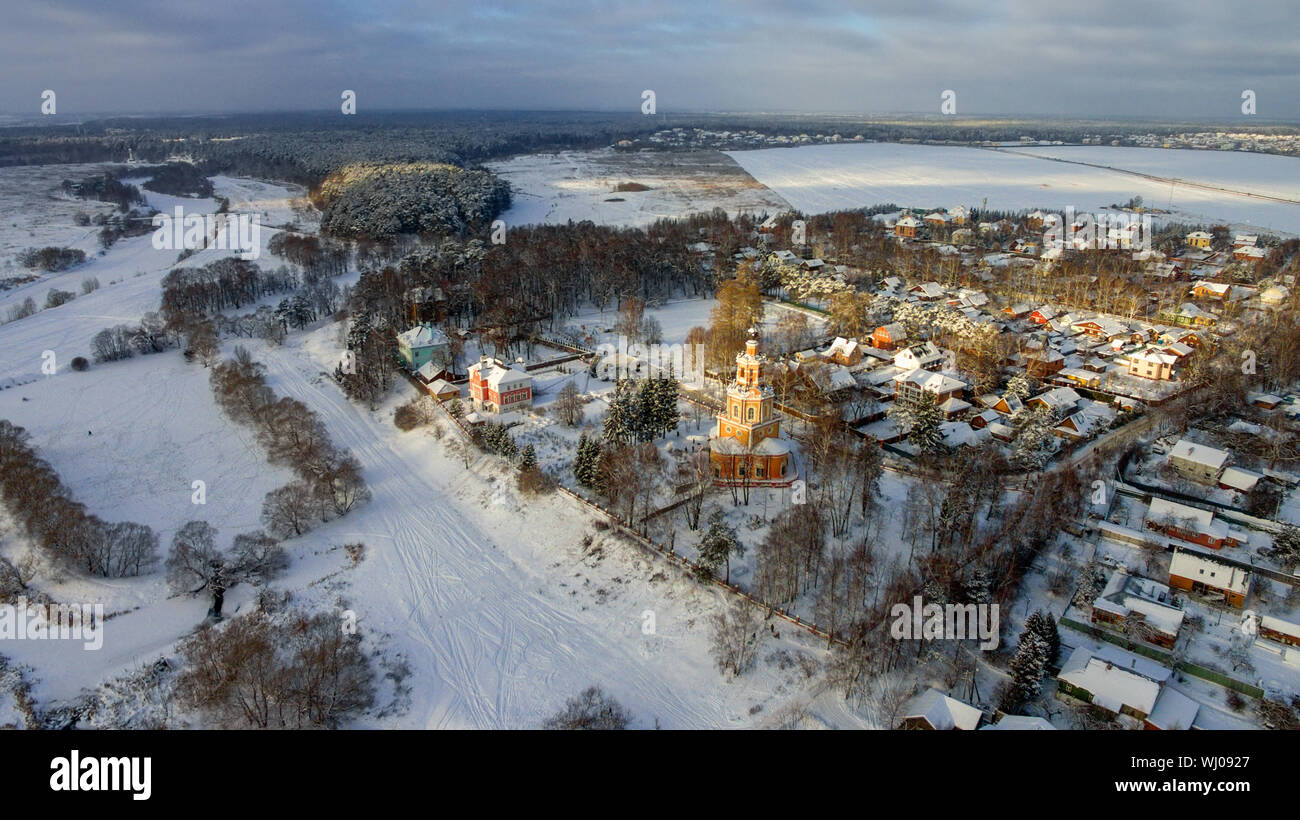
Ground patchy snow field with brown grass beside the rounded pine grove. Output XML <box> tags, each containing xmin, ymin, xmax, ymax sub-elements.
<box><xmin>486</xmin><ymin>148</ymin><xmax>789</xmax><ymax>226</ymax></box>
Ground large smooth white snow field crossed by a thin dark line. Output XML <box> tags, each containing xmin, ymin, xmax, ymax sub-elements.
<box><xmin>727</xmin><ymin>143</ymin><xmax>1300</xmax><ymax>234</ymax></box>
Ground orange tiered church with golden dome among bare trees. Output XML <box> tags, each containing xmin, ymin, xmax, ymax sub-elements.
<box><xmin>709</xmin><ymin>327</ymin><xmax>796</xmax><ymax>486</ymax></box>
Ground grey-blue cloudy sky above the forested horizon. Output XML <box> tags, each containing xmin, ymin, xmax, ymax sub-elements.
<box><xmin>0</xmin><ymin>0</ymin><xmax>1300</xmax><ymax>120</ymax></box>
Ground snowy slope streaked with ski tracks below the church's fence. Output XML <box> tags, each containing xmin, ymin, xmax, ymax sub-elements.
<box><xmin>246</xmin><ymin>327</ymin><xmax>858</xmax><ymax>728</ymax></box>
